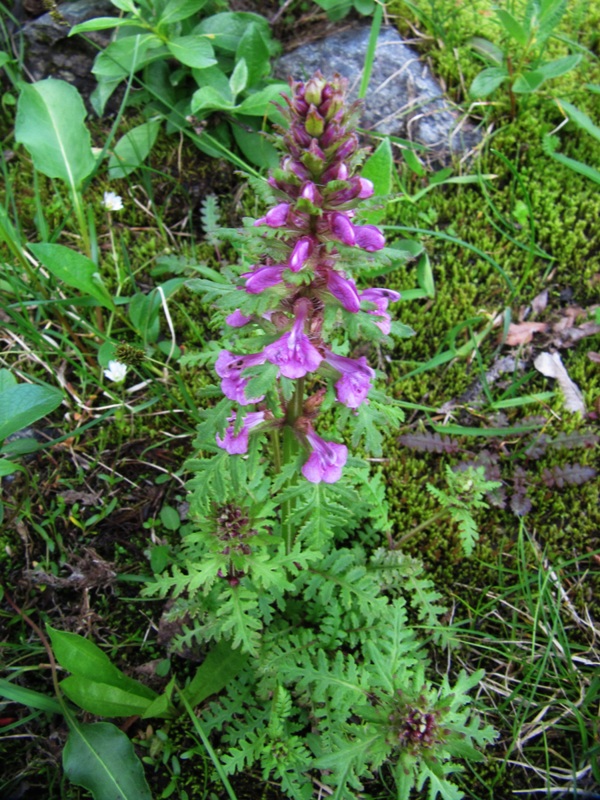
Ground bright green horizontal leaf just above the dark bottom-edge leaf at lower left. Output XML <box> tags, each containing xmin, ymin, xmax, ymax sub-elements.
<box><xmin>60</xmin><ymin>675</ymin><xmax>153</xmax><ymax>717</ymax></box>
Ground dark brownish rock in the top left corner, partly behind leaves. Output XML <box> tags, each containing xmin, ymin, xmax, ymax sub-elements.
<box><xmin>22</xmin><ymin>0</ymin><xmax>115</xmax><ymax>97</ymax></box>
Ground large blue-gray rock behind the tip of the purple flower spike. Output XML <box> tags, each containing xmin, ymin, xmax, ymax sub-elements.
<box><xmin>275</xmin><ymin>25</ymin><xmax>481</xmax><ymax>161</ymax></box>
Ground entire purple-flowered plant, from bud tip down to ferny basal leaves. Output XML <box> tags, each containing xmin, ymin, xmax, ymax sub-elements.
<box><xmin>152</xmin><ymin>74</ymin><xmax>493</xmax><ymax>800</ymax></box>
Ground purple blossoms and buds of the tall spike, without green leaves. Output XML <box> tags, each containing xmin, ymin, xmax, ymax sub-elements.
<box><xmin>216</xmin><ymin>73</ymin><xmax>400</xmax><ymax>483</ymax></box>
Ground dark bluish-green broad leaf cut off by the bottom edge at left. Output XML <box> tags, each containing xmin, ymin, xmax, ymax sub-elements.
<box><xmin>63</xmin><ymin>719</ymin><xmax>152</xmax><ymax>800</ymax></box>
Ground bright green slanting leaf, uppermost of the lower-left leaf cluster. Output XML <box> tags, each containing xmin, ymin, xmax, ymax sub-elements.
<box><xmin>46</xmin><ymin>625</ymin><xmax>156</xmax><ymax>700</ymax></box>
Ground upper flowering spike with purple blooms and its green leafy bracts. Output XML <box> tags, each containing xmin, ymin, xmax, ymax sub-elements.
<box><xmin>190</xmin><ymin>74</ymin><xmax>411</xmax><ymax>504</ymax></box>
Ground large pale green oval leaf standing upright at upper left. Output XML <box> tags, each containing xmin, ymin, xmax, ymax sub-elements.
<box><xmin>15</xmin><ymin>78</ymin><xmax>96</xmax><ymax>192</ymax></box>
